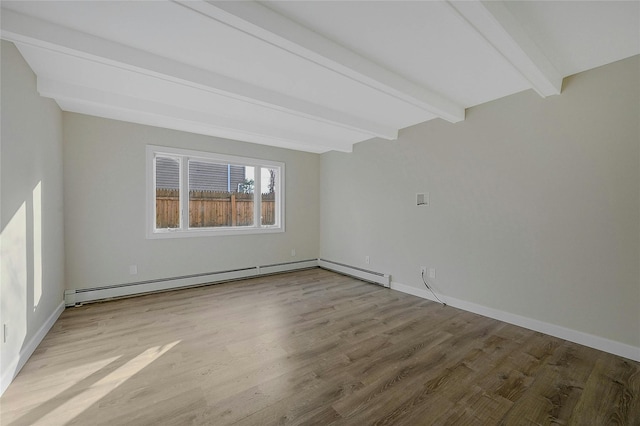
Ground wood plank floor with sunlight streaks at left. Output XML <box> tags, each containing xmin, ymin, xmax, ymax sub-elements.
<box><xmin>0</xmin><ymin>269</ymin><xmax>640</xmax><ymax>425</ymax></box>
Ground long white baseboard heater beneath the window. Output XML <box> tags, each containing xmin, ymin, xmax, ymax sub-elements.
<box><xmin>64</xmin><ymin>259</ymin><xmax>318</xmax><ymax>306</ymax></box>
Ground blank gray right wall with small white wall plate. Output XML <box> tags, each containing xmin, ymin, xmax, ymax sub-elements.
<box><xmin>320</xmin><ymin>57</ymin><xmax>640</xmax><ymax>347</ymax></box>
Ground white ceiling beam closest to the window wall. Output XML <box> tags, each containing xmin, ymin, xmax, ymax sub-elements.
<box><xmin>37</xmin><ymin>77</ymin><xmax>352</xmax><ymax>152</ymax></box>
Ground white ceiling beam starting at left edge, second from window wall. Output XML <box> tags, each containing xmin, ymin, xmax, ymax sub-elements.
<box><xmin>1</xmin><ymin>9</ymin><xmax>398</xmax><ymax>140</ymax></box>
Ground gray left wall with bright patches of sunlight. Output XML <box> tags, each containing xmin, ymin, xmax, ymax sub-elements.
<box><xmin>0</xmin><ymin>41</ymin><xmax>64</xmax><ymax>387</ymax></box>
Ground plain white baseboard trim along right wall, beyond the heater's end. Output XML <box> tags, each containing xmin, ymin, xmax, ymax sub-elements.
<box><xmin>391</xmin><ymin>282</ymin><xmax>640</xmax><ymax>361</ymax></box>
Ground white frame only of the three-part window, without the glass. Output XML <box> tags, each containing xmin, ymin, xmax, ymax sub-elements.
<box><xmin>146</xmin><ymin>145</ymin><xmax>285</xmax><ymax>239</ymax></box>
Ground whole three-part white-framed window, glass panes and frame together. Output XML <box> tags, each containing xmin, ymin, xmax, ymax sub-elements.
<box><xmin>147</xmin><ymin>145</ymin><xmax>284</xmax><ymax>238</ymax></box>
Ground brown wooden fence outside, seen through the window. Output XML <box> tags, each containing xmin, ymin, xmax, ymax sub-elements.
<box><xmin>156</xmin><ymin>189</ymin><xmax>275</xmax><ymax>228</ymax></box>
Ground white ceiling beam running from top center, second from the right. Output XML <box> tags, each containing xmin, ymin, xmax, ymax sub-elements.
<box><xmin>174</xmin><ymin>0</ymin><xmax>465</xmax><ymax>123</ymax></box>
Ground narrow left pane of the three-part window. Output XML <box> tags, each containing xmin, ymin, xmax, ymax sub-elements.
<box><xmin>155</xmin><ymin>157</ymin><xmax>180</xmax><ymax>229</ymax></box>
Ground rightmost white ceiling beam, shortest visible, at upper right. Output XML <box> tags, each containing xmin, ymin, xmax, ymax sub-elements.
<box><xmin>448</xmin><ymin>0</ymin><xmax>562</xmax><ymax>97</ymax></box>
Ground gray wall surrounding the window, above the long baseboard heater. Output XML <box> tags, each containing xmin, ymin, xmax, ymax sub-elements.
<box><xmin>63</xmin><ymin>112</ymin><xmax>320</xmax><ymax>289</ymax></box>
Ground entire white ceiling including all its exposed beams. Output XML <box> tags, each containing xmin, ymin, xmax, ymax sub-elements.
<box><xmin>1</xmin><ymin>0</ymin><xmax>640</xmax><ymax>152</ymax></box>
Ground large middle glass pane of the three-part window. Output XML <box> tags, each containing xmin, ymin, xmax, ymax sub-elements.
<box><xmin>189</xmin><ymin>160</ymin><xmax>254</xmax><ymax>228</ymax></box>
